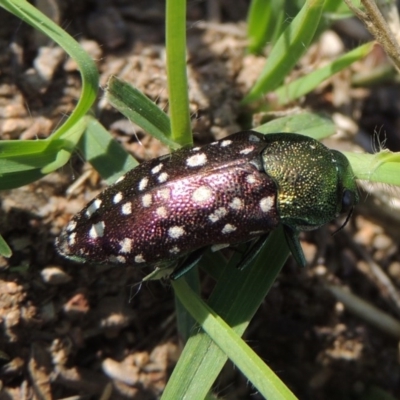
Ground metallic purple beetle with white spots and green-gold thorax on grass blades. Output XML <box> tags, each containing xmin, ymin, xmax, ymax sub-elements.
<box><xmin>57</xmin><ymin>131</ymin><xmax>359</xmax><ymax>279</ymax></box>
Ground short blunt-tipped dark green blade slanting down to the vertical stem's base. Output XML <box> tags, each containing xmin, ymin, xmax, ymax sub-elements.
<box><xmin>106</xmin><ymin>76</ymin><xmax>179</xmax><ymax>149</ymax></box>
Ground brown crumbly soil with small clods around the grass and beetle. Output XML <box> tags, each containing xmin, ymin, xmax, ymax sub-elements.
<box><xmin>0</xmin><ymin>0</ymin><xmax>400</xmax><ymax>400</ymax></box>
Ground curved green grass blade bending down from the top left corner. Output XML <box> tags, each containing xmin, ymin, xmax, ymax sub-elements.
<box><xmin>0</xmin><ymin>0</ymin><xmax>99</xmax><ymax>140</ymax></box>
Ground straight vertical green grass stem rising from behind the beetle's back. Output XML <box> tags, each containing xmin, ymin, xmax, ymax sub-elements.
<box><xmin>165</xmin><ymin>0</ymin><xmax>193</xmax><ymax>146</ymax></box>
